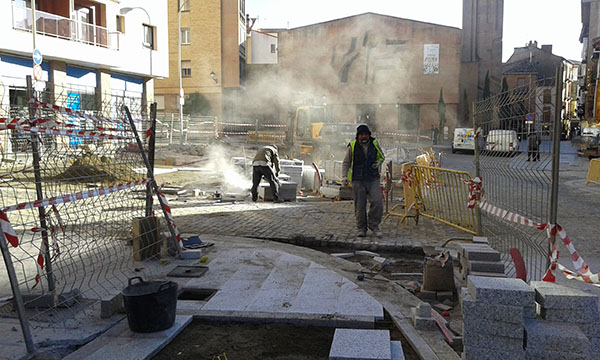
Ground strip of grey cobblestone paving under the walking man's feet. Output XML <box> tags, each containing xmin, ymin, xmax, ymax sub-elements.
<box><xmin>170</xmin><ymin>200</ymin><xmax>470</xmax><ymax>249</ymax></box>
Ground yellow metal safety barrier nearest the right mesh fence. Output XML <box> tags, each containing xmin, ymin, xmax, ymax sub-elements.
<box><xmin>413</xmin><ymin>165</ymin><xmax>477</xmax><ymax>235</ymax></box>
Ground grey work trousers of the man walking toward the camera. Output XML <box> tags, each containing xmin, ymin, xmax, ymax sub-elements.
<box><xmin>352</xmin><ymin>179</ymin><xmax>383</xmax><ymax>231</ymax></box>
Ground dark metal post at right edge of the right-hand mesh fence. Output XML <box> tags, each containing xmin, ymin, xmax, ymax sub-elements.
<box><xmin>546</xmin><ymin>65</ymin><xmax>563</xmax><ymax>266</ymax></box>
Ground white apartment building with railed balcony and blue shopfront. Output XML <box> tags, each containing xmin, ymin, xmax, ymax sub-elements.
<box><xmin>0</xmin><ymin>0</ymin><xmax>169</xmax><ymax>111</ymax></box>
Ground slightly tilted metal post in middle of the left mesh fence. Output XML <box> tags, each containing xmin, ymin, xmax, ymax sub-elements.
<box><xmin>27</xmin><ymin>75</ymin><xmax>55</xmax><ymax>293</ymax></box>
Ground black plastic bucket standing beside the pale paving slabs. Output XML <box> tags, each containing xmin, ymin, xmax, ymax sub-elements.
<box><xmin>121</xmin><ymin>276</ymin><xmax>177</xmax><ymax>333</ymax></box>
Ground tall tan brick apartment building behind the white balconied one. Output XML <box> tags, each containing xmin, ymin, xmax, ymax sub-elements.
<box><xmin>155</xmin><ymin>0</ymin><xmax>246</xmax><ymax>119</ymax></box>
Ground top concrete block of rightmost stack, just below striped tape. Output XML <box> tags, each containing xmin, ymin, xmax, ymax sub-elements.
<box><xmin>530</xmin><ymin>281</ymin><xmax>598</xmax><ymax>309</ymax></box>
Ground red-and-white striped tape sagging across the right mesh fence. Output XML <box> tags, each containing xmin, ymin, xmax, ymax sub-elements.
<box><xmin>469</xmin><ymin>178</ymin><xmax>600</xmax><ymax>286</ymax></box>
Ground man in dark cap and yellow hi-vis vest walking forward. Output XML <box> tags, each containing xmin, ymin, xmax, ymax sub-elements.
<box><xmin>342</xmin><ymin>125</ymin><xmax>385</xmax><ymax>237</ymax></box>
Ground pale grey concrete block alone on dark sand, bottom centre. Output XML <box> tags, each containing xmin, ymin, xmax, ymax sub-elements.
<box><xmin>329</xmin><ymin>329</ymin><xmax>392</xmax><ymax>360</ymax></box>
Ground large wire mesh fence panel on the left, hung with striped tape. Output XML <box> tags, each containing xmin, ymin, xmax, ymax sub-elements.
<box><xmin>0</xmin><ymin>78</ymin><xmax>176</xmax><ymax>350</ymax></box>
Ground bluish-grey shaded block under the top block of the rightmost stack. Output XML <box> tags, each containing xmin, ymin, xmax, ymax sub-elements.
<box><xmin>523</xmin><ymin>319</ymin><xmax>590</xmax><ymax>354</ymax></box>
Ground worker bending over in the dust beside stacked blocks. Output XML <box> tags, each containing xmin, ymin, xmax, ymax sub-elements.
<box><xmin>251</xmin><ymin>145</ymin><xmax>283</xmax><ymax>202</ymax></box>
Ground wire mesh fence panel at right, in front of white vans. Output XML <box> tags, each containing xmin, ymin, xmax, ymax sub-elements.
<box><xmin>473</xmin><ymin>74</ymin><xmax>562</xmax><ymax>280</ymax></box>
